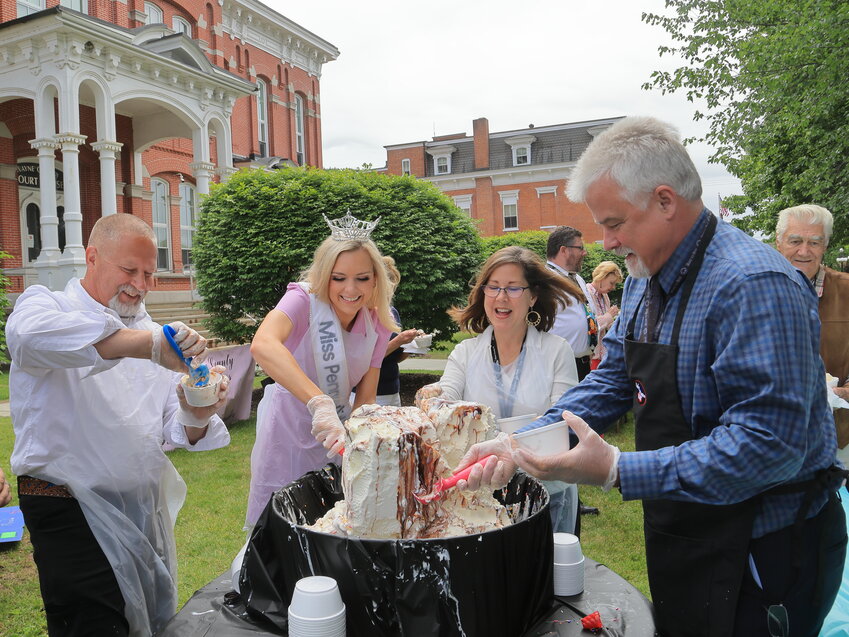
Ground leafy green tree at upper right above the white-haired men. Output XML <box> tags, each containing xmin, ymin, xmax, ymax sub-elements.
<box><xmin>643</xmin><ymin>0</ymin><xmax>849</xmax><ymax>245</ymax></box>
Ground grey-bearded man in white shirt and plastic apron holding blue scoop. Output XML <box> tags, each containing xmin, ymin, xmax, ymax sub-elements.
<box><xmin>6</xmin><ymin>214</ymin><xmax>230</xmax><ymax>637</ymax></box>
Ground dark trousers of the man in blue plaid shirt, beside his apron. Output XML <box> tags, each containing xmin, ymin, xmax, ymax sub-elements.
<box><xmin>734</xmin><ymin>494</ymin><xmax>846</xmax><ymax>637</ymax></box>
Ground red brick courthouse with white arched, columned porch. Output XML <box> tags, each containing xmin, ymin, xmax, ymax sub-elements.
<box><xmin>0</xmin><ymin>0</ymin><xmax>339</xmax><ymax>302</ymax></box>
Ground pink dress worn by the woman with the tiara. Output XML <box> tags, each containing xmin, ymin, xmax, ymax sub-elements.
<box><xmin>247</xmin><ymin>283</ymin><xmax>389</xmax><ymax>525</ymax></box>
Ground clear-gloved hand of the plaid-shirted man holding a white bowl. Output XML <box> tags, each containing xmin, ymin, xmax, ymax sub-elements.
<box><xmin>513</xmin><ymin>411</ymin><xmax>620</xmax><ymax>491</ymax></box>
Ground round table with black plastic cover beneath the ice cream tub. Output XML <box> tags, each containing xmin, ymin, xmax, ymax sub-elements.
<box><xmin>157</xmin><ymin>558</ymin><xmax>655</xmax><ymax>637</ymax></box>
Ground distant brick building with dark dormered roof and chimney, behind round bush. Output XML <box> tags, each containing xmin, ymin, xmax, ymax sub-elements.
<box><xmin>382</xmin><ymin>117</ymin><xmax>621</xmax><ymax>242</ymax></box>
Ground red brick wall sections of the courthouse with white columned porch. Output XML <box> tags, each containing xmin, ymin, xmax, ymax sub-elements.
<box><xmin>0</xmin><ymin>0</ymin><xmax>338</xmax><ymax>293</ymax></box>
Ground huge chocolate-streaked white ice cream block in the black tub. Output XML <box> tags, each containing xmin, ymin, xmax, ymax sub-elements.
<box><xmin>311</xmin><ymin>400</ymin><xmax>510</xmax><ymax>539</ymax></box>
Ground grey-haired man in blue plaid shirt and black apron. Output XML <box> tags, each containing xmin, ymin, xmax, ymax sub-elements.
<box><xmin>458</xmin><ymin>118</ymin><xmax>846</xmax><ymax>637</ymax></box>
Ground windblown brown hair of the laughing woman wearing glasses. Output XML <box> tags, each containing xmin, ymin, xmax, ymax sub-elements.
<box><xmin>448</xmin><ymin>246</ymin><xmax>584</xmax><ymax>334</ymax></box>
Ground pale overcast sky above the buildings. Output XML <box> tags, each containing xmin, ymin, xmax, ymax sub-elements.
<box><xmin>270</xmin><ymin>0</ymin><xmax>742</xmax><ymax>209</ymax></box>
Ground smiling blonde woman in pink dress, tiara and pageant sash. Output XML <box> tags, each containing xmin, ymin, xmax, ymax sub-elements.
<box><xmin>242</xmin><ymin>214</ymin><xmax>398</xmax><ymax>526</ymax></box>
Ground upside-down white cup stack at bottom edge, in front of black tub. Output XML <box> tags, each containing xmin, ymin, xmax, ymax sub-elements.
<box><xmin>289</xmin><ymin>575</ymin><xmax>345</xmax><ymax>637</ymax></box>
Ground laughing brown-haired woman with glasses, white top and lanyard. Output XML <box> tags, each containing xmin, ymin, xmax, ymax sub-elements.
<box><xmin>439</xmin><ymin>246</ymin><xmax>578</xmax><ymax>533</ymax></box>
